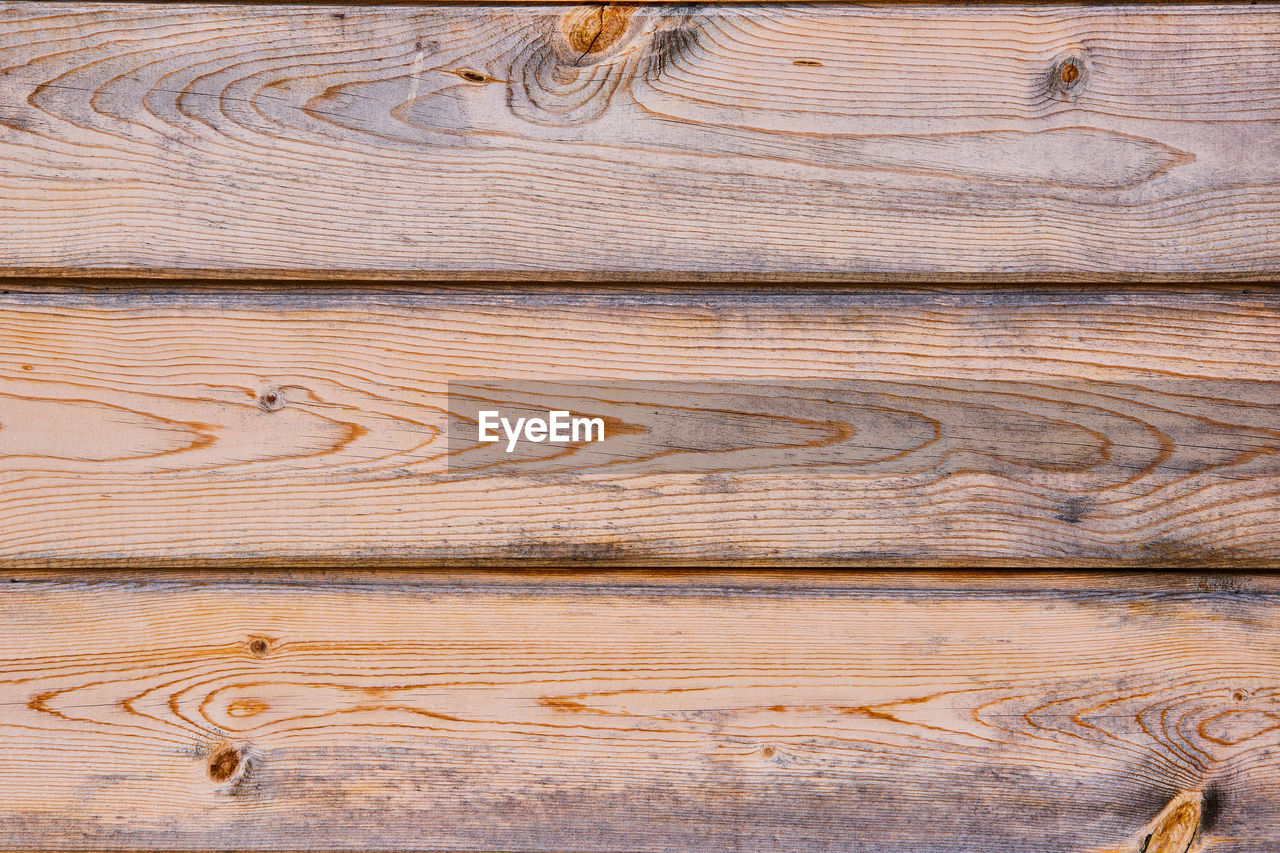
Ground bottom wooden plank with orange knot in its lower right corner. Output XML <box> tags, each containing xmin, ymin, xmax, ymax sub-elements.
<box><xmin>0</xmin><ymin>573</ymin><xmax>1280</xmax><ymax>853</ymax></box>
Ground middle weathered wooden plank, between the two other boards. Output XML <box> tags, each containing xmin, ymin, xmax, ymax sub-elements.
<box><xmin>0</xmin><ymin>283</ymin><xmax>1280</xmax><ymax>566</ymax></box>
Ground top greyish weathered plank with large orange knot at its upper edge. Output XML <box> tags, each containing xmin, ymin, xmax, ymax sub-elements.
<box><xmin>0</xmin><ymin>3</ymin><xmax>1280</xmax><ymax>280</ymax></box>
